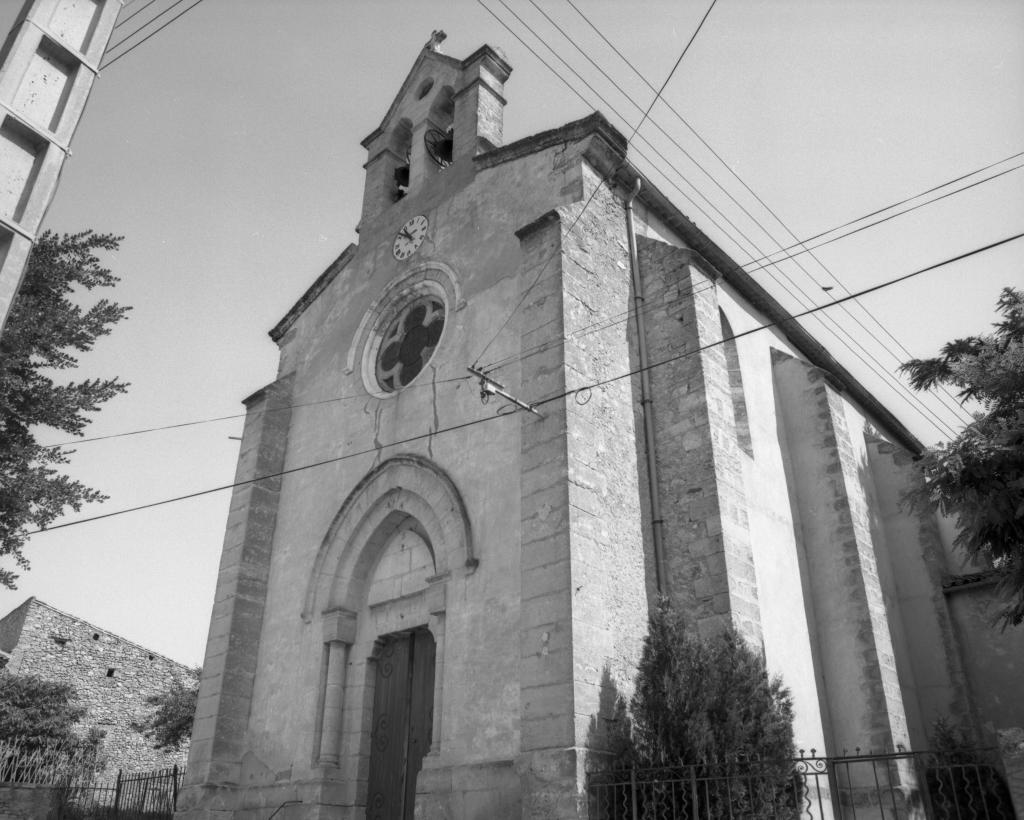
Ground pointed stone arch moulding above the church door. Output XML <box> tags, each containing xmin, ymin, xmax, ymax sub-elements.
<box><xmin>302</xmin><ymin>455</ymin><xmax>477</xmax><ymax>622</ymax></box>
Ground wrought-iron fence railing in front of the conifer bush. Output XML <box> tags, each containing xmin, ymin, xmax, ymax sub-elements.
<box><xmin>587</xmin><ymin>749</ymin><xmax>1015</xmax><ymax>820</ymax></box>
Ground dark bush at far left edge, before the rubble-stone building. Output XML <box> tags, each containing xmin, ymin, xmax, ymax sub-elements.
<box><xmin>0</xmin><ymin>673</ymin><xmax>85</xmax><ymax>747</ymax></box>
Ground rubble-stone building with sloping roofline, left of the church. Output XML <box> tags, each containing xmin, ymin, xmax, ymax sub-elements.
<box><xmin>0</xmin><ymin>598</ymin><xmax>195</xmax><ymax>774</ymax></box>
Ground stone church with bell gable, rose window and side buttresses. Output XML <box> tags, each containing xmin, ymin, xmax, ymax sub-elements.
<box><xmin>178</xmin><ymin>36</ymin><xmax>1024</xmax><ymax>820</ymax></box>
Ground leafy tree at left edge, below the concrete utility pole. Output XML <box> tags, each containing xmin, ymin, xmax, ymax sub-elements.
<box><xmin>0</xmin><ymin>230</ymin><xmax>130</xmax><ymax>589</ymax></box>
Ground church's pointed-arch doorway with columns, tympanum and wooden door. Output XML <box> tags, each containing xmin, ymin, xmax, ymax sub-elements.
<box><xmin>303</xmin><ymin>456</ymin><xmax>477</xmax><ymax>820</ymax></box>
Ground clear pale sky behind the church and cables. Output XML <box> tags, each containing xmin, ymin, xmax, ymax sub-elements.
<box><xmin>0</xmin><ymin>0</ymin><xmax>1024</xmax><ymax>664</ymax></box>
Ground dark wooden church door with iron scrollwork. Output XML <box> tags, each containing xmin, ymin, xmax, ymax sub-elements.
<box><xmin>367</xmin><ymin>630</ymin><xmax>434</xmax><ymax>820</ymax></box>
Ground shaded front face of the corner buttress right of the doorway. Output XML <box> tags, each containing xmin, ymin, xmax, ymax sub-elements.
<box><xmin>516</xmin><ymin>211</ymin><xmax>578</xmax><ymax>820</ymax></box>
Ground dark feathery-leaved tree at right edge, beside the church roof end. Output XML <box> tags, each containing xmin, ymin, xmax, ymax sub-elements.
<box><xmin>901</xmin><ymin>288</ymin><xmax>1024</xmax><ymax>629</ymax></box>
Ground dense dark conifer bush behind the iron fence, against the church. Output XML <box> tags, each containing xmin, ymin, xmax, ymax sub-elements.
<box><xmin>596</xmin><ymin>603</ymin><xmax>802</xmax><ymax>820</ymax></box>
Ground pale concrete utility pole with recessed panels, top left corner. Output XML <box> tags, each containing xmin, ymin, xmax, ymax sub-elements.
<box><xmin>0</xmin><ymin>0</ymin><xmax>123</xmax><ymax>331</ymax></box>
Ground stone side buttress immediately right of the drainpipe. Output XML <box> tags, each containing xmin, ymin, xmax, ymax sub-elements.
<box><xmin>638</xmin><ymin>238</ymin><xmax>761</xmax><ymax>646</ymax></box>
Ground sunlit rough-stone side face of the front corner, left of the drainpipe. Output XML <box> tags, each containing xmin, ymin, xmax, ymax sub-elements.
<box><xmin>562</xmin><ymin>177</ymin><xmax>654</xmax><ymax>782</ymax></box>
